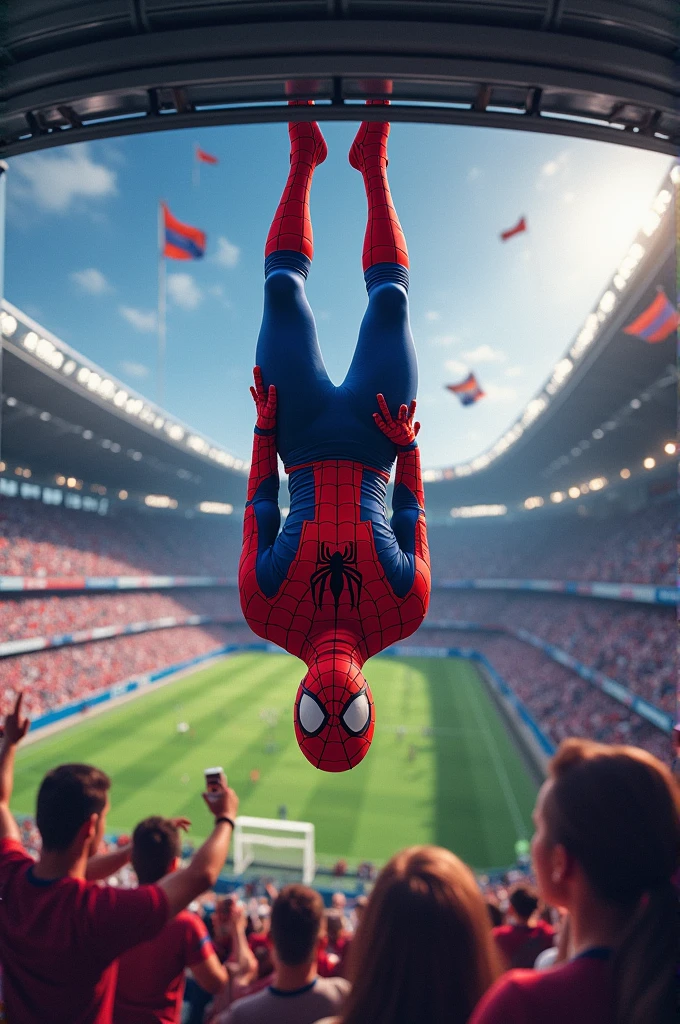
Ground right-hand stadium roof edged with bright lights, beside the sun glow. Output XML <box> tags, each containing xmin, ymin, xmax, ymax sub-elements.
<box><xmin>424</xmin><ymin>172</ymin><xmax>680</xmax><ymax>512</ymax></box>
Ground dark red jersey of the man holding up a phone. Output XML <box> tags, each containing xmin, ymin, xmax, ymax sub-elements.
<box><xmin>0</xmin><ymin>839</ymin><xmax>168</xmax><ymax>1024</ymax></box>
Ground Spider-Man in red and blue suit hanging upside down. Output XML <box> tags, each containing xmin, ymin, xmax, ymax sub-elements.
<box><xmin>239</xmin><ymin>101</ymin><xmax>430</xmax><ymax>771</ymax></box>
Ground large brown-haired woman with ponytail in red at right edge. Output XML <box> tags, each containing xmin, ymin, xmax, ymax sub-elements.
<box><xmin>470</xmin><ymin>739</ymin><xmax>680</xmax><ymax>1024</ymax></box>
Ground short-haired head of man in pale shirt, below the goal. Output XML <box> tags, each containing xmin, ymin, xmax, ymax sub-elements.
<box><xmin>270</xmin><ymin>885</ymin><xmax>325</xmax><ymax>967</ymax></box>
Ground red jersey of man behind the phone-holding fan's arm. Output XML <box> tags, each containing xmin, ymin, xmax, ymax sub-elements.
<box><xmin>114</xmin><ymin>910</ymin><xmax>215</xmax><ymax>1024</ymax></box>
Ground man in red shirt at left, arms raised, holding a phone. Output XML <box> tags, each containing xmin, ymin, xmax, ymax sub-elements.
<box><xmin>0</xmin><ymin>694</ymin><xmax>238</xmax><ymax>1024</ymax></box>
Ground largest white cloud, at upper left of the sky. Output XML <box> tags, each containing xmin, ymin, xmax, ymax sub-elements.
<box><xmin>12</xmin><ymin>144</ymin><xmax>118</xmax><ymax>213</ymax></box>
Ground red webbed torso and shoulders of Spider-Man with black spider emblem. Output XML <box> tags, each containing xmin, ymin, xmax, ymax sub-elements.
<box><xmin>240</xmin><ymin>462</ymin><xmax>430</xmax><ymax>664</ymax></box>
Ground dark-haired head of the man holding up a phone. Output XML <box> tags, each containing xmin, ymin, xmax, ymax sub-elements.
<box><xmin>36</xmin><ymin>764</ymin><xmax>111</xmax><ymax>863</ymax></box>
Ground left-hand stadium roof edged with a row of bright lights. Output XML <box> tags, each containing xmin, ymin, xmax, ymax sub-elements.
<box><xmin>0</xmin><ymin>302</ymin><xmax>248</xmax><ymax>507</ymax></box>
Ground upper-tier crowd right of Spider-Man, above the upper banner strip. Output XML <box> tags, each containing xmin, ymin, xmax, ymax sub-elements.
<box><xmin>428</xmin><ymin>501</ymin><xmax>676</xmax><ymax>586</ymax></box>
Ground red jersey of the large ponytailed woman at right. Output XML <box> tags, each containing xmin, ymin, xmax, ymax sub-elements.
<box><xmin>468</xmin><ymin>949</ymin><xmax>614</xmax><ymax>1024</ymax></box>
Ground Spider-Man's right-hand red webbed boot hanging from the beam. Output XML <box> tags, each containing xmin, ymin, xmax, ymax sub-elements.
<box><xmin>349</xmin><ymin>116</ymin><xmax>409</xmax><ymax>270</ymax></box>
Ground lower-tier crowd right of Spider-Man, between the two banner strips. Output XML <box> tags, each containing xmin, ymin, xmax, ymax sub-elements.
<box><xmin>428</xmin><ymin>591</ymin><xmax>678</xmax><ymax>713</ymax></box>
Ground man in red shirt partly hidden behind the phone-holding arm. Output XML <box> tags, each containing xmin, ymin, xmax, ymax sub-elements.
<box><xmin>114</xmin><ymin>817</ymin><xmax>228</xmax><ymax>1024</ymax></box>
